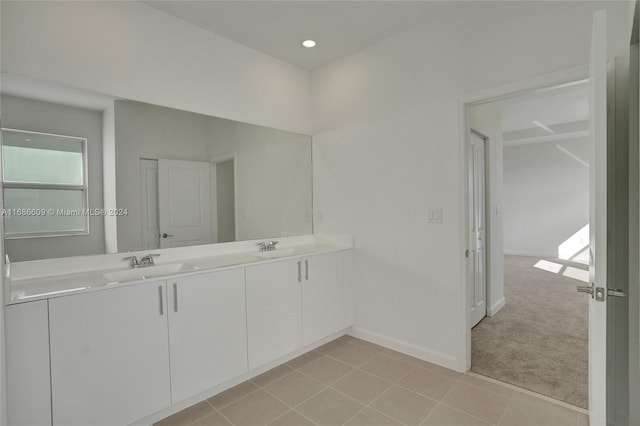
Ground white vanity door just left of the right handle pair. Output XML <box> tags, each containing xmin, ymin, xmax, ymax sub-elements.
<box><xmin>246</xmin><ymin>259</ymin><xmax>303</xmax><ymax>369</ymax></box>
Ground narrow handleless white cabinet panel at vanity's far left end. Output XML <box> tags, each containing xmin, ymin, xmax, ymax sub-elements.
<box><xmin>4</xmin><ymin>300</ymin><xmax>51</xmax><ymax>426</ymax></box>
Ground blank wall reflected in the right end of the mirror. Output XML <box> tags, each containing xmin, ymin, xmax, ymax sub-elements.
<box><xmin>207</xmin><ymin>118</ymin><xmax>313</xmax><ymax>241</ymax></box>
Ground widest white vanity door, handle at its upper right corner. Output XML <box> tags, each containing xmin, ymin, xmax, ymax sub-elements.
<box><xmin>49</xmin><ymin>281</ymin><xmax>171</xmax><ymax>426</ymax></box>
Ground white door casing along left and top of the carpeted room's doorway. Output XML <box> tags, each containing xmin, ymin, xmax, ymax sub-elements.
<box><xmin>455</xmin><ymin>65</ymin><xmax>589</xmax><ymax>371</ymax></box>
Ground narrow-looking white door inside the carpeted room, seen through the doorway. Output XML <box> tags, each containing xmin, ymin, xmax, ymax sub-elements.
<box><xmin>467</xmin><ymin>131</ymin><xmax>487</xmax><ymax>327</ymax></box>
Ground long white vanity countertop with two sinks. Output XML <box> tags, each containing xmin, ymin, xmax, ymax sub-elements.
<box><xmin>7</xmin><ymin>242</ymin><xmax>351</xmax><ymax>305</ymax></box>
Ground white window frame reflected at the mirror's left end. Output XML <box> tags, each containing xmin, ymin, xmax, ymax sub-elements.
<box><xmin>0</xmin><ymin>127</ymin><xmax>89</xmax><ymax>240</ymax></box>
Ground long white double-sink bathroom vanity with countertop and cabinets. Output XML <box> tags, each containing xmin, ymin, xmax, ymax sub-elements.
<box><xmin>6</xmin><ymin>236</ymin><xmax>353</xmax><ymax>425</ymax></box>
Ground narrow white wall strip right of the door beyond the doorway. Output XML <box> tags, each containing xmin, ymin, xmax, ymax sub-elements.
<box><xmin>468</xmin><ymin>102</ymin><xmax>505</xmax><ymax>316</ymax></box>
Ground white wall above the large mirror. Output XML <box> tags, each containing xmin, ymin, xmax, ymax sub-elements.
<box><xmin>1</xmin><ymin>1</ymin><xmax>311</xmax><ymax>134</ymax></box>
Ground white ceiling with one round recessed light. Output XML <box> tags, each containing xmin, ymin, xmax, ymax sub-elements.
<box><xmin>143</xmin><ymin>0</ymin><xmax>450</xmax><ymax>70</ymax></box>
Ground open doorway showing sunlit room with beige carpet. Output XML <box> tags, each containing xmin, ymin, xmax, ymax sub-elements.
<box><xmin>468</xmin><ymin>80</ymin><xmax>590</xmax><ymax>409</ymax></box>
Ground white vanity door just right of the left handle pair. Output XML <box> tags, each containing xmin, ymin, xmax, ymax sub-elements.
<box><xmin>167</xmin><ymin>269</ymin><xmax>247</xmax><ymax>403</ymax></box>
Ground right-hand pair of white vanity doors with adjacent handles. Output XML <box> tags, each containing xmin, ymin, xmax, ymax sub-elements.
<box><xmin>246</xmin><ymin>252</ymin><xmax>346</xmax><ymax>369</ymax></box>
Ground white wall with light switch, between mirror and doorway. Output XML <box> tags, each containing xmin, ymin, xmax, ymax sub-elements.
<box><xmin>312</xmin><ymin>2</ymin><xmax>628</xmax><ymax>369</ymax></box>
